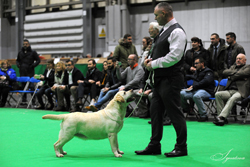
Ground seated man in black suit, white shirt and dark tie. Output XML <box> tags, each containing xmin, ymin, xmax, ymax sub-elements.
<box><xmin>55</xmin><ymin>60</ymin><xmax>84</xmax><ymax>111</ymax></box>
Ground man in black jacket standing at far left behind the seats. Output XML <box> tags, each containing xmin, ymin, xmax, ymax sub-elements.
<box><xmin>16</xmin><ymin>39</ymin><xmax>41</xmax><ymax>103</ymax></box>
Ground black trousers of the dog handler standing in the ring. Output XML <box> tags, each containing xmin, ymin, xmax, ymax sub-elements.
<box><xmin>149</xmin><ymin>74</ymin><xmax>187</xmax><ymax>149</ymax></box>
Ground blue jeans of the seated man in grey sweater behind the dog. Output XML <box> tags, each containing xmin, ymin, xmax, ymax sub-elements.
<box><xmin>94</xmin><ymin>89</ymin><xmax>119</xmax><ymax>109</ymax></box>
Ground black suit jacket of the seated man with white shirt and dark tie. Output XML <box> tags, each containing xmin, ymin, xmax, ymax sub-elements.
<box><xmin>62</xmin><ymin>67</ymin><xmax>84</xmax><ymax>89</ymax></box>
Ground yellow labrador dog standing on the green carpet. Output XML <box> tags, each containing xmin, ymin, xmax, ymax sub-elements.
<box><xmin>42</xmin><ymin>90</ymin><xmax>134</xmax><ymax>157</ymax></box>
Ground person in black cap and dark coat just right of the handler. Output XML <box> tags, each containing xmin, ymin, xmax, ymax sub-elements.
<box><xmin>184</xmin><ymin>37</ymin><xmax>210</xmax><ymax>75</ymax></box>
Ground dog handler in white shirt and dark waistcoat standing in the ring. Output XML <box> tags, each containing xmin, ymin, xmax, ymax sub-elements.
<box><xmin>135</xmin><ymin>2</ymin><xmax>188</xmax><ymax>157</ymax></box>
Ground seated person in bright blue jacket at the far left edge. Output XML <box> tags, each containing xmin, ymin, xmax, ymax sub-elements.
<box><xmin>0</xmin><ymin>60</ymin><xmax>16</xmax><ymax>107</ymax></box>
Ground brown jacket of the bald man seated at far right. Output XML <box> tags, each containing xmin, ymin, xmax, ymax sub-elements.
<box><xmin>223</xmin><ymin>64</ymin><xmax>250</xmax><ymax>98</ymax></box>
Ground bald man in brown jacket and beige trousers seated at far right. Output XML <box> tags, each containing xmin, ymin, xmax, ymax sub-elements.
<box><xmin>213</xmin><ymin>53</ymin><xmax>250</xmax><ymax>126</ymax></box>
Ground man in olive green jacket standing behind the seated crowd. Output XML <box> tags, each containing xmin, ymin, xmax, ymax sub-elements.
<box><xmin>113</xmin><ymin>34</ymin><xmax>138</xmax><ymax>71</ymax></box>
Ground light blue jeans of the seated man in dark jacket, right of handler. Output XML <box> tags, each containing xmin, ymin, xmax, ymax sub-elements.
<box><xmin>181</xmin><ymin>89</ymin><xmax>211</xmax><ymax>117</ymax></box>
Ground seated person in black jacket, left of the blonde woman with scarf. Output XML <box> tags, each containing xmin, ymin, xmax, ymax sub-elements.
<box><xmin>34</xmin><ymin>60</ymin><xmax>55</xmax><ymax>110</ymax></box>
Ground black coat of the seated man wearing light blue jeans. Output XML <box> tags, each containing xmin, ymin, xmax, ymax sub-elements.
<box><xmin>186</xmin><ymin>67</ymin><xmax>215</xmax><ymax>96</ymax></box>
